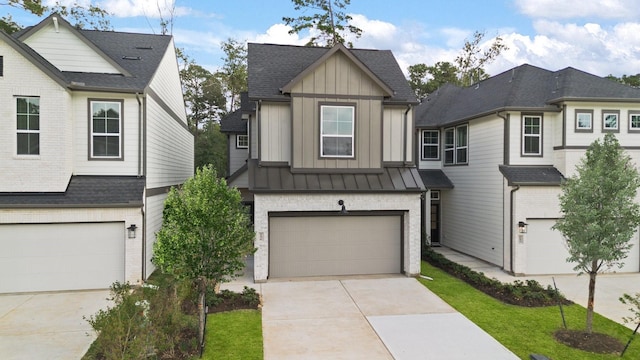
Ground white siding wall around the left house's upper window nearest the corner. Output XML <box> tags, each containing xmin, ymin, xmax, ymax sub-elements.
<box><xmin>71</xmin><ymin>92</ymin><xmax>140</xmax><ymax>176</ymax></box>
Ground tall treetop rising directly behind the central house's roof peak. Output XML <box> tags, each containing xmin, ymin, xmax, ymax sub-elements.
<box><xmin>282</xmin><ymin>0</ymin><xmax>362</xmax><ymax>47</ymax></box>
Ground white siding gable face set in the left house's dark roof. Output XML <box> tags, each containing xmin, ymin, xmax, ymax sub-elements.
<box><xmin>24</xmin><ymin>22</ymin><xmax>120</xmax><ymax>74</ymax></box>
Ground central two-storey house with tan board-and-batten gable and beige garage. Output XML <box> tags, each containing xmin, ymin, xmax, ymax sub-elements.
<box><xmin>238</xmin><ymin>44</ymin><xmax>424</xmax><ymax>282</ymax></box>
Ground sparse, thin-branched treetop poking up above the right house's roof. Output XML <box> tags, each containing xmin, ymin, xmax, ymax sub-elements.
<box><xmin>455</xmin><ymin>31</ymin><xmax>508</xmax><ymax>86</ymax></box>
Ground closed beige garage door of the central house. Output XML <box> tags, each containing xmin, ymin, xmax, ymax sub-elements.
<box><xmin>269</xmin><ymin>215</ymin><xmax>402</xmax><ymax>278</ymax></box>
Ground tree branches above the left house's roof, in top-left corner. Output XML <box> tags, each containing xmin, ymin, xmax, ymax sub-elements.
<box><xmin>0</xmin><ymin>0</ymin><xmax>112</xmax><ymax>34</ymax></box>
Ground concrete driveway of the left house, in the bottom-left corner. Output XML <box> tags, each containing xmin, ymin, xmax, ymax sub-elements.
<box><xmin>0</xmin><ymin>290</ymin><xmax>109</xmax><ymax>360</ymax></box>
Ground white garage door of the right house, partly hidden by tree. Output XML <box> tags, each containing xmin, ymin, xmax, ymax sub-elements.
<box><xmin>525</xmin><ymin>219</ymin><xmax>640</xmax><ymax>275</ymax></box>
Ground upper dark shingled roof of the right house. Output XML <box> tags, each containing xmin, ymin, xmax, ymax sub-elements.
<box><xmin>416</xmin><ymin>64</ymin><xmax>640</xmax><ymax>127</ymax></box>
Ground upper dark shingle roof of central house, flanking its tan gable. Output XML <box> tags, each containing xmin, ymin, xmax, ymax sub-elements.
<box><xmin>248</xmin><ymin>43</ymin><xmax>417</xmax><ymax>103</ymax></box>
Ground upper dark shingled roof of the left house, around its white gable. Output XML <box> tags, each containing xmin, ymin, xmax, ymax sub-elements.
<box><xmin>0</xmin><ymin>15</ymin><xmax>172</xmax><ymax>93</ymax></box>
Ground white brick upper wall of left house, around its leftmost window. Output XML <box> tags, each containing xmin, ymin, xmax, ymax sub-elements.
<box><xmin>0</xmin><ymin>42</ymin><xmax>73</xmax><ymax>192</ymax></box>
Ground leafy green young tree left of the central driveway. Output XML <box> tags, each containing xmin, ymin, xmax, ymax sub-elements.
<box><xmin>151</xmin><ymin>166</ymin><xmax>254</xmax><ymax>346</ymax></box>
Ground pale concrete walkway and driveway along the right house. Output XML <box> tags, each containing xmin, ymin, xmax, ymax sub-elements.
<box><xmin>432</xmin><ymin>247</ymin><xmax>640</xmax><ymax>329</ymax></box>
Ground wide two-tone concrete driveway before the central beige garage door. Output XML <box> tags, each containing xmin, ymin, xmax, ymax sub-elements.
<box><xmin>262</xmin><ymin>277</ymin><xmax>517</xmax><ymax>360</ymax></box>
